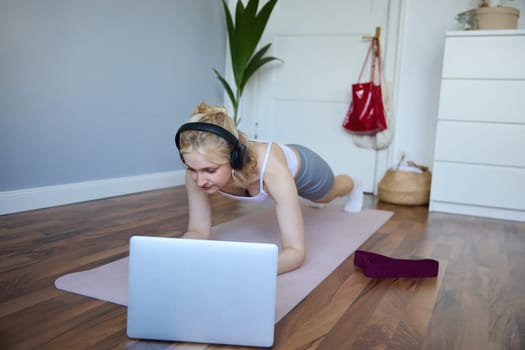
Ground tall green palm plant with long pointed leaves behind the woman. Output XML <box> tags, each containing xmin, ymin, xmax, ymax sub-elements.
<box><xmin>213</xmin><ymin>0</ymin><xmax>278</xmax><ymax>125</ymax></box>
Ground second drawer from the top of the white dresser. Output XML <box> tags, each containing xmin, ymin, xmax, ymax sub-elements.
<box><xmin>439</xmin><ymin>79</ymin><xmax>525</xmax><ymax>124</ymax></box>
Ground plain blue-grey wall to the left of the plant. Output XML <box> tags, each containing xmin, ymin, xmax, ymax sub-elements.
<box><xmin>0</xmin><ymin>0</ymin><xmax>226</xmax><ymax>191</ymax></box>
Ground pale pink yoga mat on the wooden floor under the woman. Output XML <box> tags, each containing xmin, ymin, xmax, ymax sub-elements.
<box><xmin>55</xmin><ymin>204</ymin><xmax>392</xmax><ymax>323</ymax></box>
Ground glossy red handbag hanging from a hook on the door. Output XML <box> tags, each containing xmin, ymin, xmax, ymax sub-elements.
<box><xmin>343</xmin><ymin>38</ymin><xmax>387</xmax><ymax>135</ymax></box>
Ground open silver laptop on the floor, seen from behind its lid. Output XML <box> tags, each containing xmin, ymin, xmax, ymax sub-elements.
<box><xmin>127</xmin><ymin>236</ymin><xmax>278</xmax><ymax>347</ymax></box>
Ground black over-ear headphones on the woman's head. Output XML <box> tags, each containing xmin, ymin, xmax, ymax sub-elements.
<box><xmin>175</xmin><ymin>122</ymin><xmax>248</xmax><ymax>170</ymax></box>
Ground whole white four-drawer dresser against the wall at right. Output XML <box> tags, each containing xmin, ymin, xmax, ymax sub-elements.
<box><xmin>429</xmin><ymin>30</ymin><xmax>525</xmax><ymax>221</ymax></box>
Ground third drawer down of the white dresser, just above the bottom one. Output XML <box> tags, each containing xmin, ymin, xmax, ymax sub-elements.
<box><xmin>434</xmin><ymin>121</ymin><xmax>525</xmax><ymax>167</ymax></box>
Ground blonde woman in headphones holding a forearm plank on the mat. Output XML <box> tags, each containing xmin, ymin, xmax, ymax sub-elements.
<box><xmin>175</xmin><ymin>103</ymin><xmax>363</xmax><ymax>273</ymax></box>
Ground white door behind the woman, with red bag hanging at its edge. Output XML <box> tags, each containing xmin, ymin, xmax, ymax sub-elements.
<box><xmin>231</xmin><ymin>0</ymin><xmax>399</xmax><ymax>192</ymax></box>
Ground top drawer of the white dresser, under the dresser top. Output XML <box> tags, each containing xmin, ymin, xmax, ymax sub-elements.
<box><xmin>442</xmin><ymin>35</ymin><xmax>525</xmax><ymax>79</ymax></box>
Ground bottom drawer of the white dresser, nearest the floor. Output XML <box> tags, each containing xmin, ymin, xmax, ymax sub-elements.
<box><xmin>430</xmin><ymin>161</ymin><xmax>525</xmax><ymax>210</ymax></box>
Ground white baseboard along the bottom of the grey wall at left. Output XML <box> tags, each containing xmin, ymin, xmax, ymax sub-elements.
<box><xmin>0</xmin><ymin>170</ymin><xmax>185</xmax><ymax>215</ymax></box>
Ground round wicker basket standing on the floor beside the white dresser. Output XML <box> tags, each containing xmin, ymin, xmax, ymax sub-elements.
<box><xmin>378</xmin><ymin>162</ymin><xmax>432</xmax><ymax>205</ymax></box>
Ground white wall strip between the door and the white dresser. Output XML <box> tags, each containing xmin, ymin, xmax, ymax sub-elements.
<box><xmin>391</xmin><ymin>0</ymin><xmax>525</xmax><ymax>166</ymax></box>
